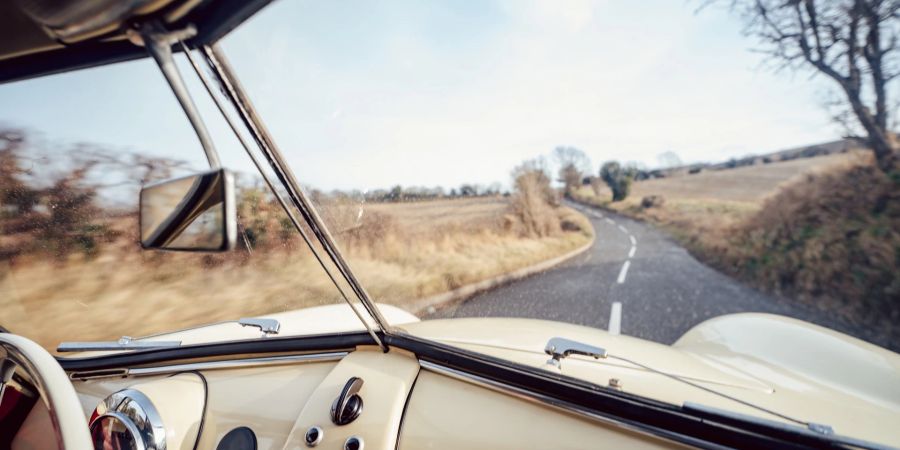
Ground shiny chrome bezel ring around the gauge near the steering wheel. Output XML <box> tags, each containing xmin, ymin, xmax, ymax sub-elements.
<box><xmin>89</xmin><ymin>389</ymin><xmax>166</xmax><ymax>450</ymax></box>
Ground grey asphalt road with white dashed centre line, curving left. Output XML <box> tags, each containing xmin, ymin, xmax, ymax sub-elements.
<box><xmin>429</xmin><ymin>201</ymin><xmax>853</xmax><ymax>344</ymax></box>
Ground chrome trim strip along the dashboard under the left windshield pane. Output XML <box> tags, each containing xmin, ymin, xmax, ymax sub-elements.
<box><xmin>69</xmin><ymin>352</ymin><xmax>349</xmax><ymax>381</ymax></box>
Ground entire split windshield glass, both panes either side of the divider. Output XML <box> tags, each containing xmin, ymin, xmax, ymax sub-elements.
<box><xmin>0</xmin><ymin>1</ymin><xmax>900</xmax><ymax>446</ymax></box>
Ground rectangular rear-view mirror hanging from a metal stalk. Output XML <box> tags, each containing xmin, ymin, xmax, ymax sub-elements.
<box><xmin>140</xmin><ymin>169</ymin><xmax>237</xmax><ymax>252</ymax></box>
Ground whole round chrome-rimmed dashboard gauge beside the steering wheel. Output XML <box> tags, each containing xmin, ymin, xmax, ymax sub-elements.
<box><xmin>90</xmin><ymin>389</ymin><xmax>166</xmax><ymax>450</ymax></box>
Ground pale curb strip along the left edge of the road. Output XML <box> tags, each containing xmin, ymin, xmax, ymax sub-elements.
<box><xmin>409</xmin><ymin>232</ymin><xmax>597</xmax><ymax>316</ymax></box>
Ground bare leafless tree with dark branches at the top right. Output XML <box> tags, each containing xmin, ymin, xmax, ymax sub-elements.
<box><xmin>730</xmin><ymin>0</ymin><xmax>900</xmax><ymax>172</ymax></box>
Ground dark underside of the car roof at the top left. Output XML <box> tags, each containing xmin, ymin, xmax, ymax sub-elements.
<box><xmin>0</xmin><ymin>0</ymin><xmax>271</xmax><ymax>83</ymax></box>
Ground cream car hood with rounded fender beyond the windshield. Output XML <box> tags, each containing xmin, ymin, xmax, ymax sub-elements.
<box><xmin>73</xmin><ymin>304</ymin><xmax>900</xmax><ymax>443</ymax></box>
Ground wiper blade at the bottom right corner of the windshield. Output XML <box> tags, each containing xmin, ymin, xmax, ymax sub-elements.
<box><xmin>681</xmin><ymin>402</ymin><xmax>894</xmax><ymax>449</ymax></box>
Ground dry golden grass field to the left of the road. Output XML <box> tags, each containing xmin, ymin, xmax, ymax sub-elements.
<box><xmin>0</xmin><ymin>197</ymin><xmax>592</xmax><ymax>349</ymax></box>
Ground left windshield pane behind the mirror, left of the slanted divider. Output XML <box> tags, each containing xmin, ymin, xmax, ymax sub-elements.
<box><xmin>0</xmin><ymin>48</ymin><xmax>384</xmax><ymax>351</ymax></box>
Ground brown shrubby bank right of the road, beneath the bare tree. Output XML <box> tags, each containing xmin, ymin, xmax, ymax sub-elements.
<box><xmin>717</xmin><ymin>158</ymin><xmax>900</xmax><ymax>337</ymax></box>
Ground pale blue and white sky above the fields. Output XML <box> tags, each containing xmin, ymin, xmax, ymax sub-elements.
<box><xmin>0</xmin><ymin>0</ymin><xmax>840</xmax><ymax>190</ymax></box>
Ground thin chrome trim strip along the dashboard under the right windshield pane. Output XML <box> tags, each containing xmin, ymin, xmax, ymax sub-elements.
<box><xmin>419</xmin><ymin>360</ymin><xmax>724</xmax><ymax>448</ymax></box>
